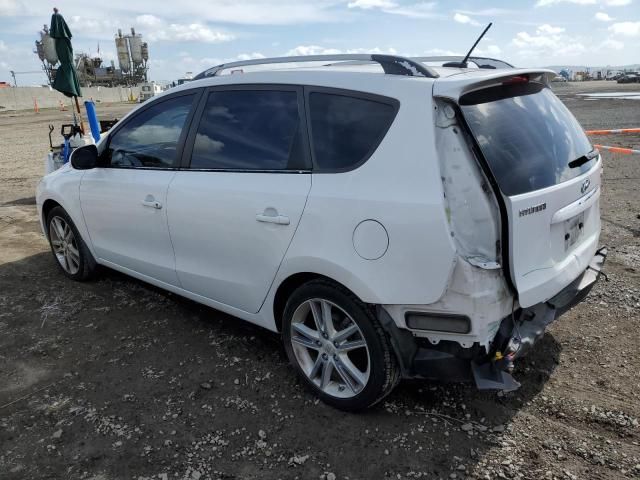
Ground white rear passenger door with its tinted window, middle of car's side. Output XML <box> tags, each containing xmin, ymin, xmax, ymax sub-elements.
<box><xmin>168</xmin><ymin>85</ymin><xmax>311</xmax><ymax>313</ymax></box>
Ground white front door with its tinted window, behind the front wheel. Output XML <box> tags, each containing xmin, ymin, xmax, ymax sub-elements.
<box><xmin>80</xmin><ymin>91</ymin><xmax>196</xmax><ymax>285</ymax></box>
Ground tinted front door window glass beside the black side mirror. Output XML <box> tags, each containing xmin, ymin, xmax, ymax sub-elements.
<box><xmin>105</xmin><ymin>95</ymin><xmax>194</xmax><ymax>168</ymax></box>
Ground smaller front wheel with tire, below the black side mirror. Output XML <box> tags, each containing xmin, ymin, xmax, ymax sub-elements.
<box><xmin>47</xmin><ymin>207</ymin><xmax>96</xmax><ymax>281</ymax></box>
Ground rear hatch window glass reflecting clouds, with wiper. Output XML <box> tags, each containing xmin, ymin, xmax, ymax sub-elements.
<box><xmin>460</xmin><ymin>83</ymin><xmax>596</xmax><ymax>196</ymax></box>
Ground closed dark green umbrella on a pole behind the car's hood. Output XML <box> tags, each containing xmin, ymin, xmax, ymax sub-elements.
<box><xmin>49</xmin><ymin>8</ymin><xmax>84</xmax><ymax>132</ymax></box>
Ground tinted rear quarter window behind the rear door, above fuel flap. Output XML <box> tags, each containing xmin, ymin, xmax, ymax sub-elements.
<box><xmin>309</xmin><ymin>92</ymin><xmax>398</xmax><ymax>171</ymax></box>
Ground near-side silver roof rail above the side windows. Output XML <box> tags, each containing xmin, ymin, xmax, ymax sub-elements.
<box><xmin>194</xmin><ymin>54</ymin><xmax>438</xmax><ymax>80</ymax></box>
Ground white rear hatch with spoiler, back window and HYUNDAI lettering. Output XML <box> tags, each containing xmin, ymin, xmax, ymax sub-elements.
<box><xmin>434</xmin><ymin>70</ymin><xmax>601</xmax><ymax>307</ymax></box>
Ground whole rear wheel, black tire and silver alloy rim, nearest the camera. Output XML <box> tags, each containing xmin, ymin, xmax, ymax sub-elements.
<box><xmin>283</xmin><ymin>280</ymin><xmax>400</xmax><ymax>411</ymax></box>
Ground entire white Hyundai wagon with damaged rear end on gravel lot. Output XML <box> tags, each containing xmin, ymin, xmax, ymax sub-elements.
<box><xmin>37</xmin><ymin>55</ymin><xmax>606</xmax><ymax>410</ymax></box>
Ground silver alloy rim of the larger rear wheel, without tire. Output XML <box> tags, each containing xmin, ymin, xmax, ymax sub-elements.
<box><xmin>290</xmin><ymin>298</ymin><xmax>371</xmax><ymax>398</ymax></box>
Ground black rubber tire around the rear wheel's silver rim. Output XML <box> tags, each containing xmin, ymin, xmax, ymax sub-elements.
<box><xmin>282</xmin><ymin>279</ymin><xmax>400</xmax><ymax>411</ymax></box>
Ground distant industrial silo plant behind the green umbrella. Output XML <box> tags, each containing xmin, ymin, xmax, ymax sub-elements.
<box><xmin>34</xmin><ymin>25</ymin><xmax>149</xmax><ymax>87</ymax></box>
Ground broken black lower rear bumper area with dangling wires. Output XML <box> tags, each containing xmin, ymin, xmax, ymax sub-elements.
<box><xmin>379</xmin><ymin>248</ymin><xmax>607</xmax><ymax>390</ymax></box>
